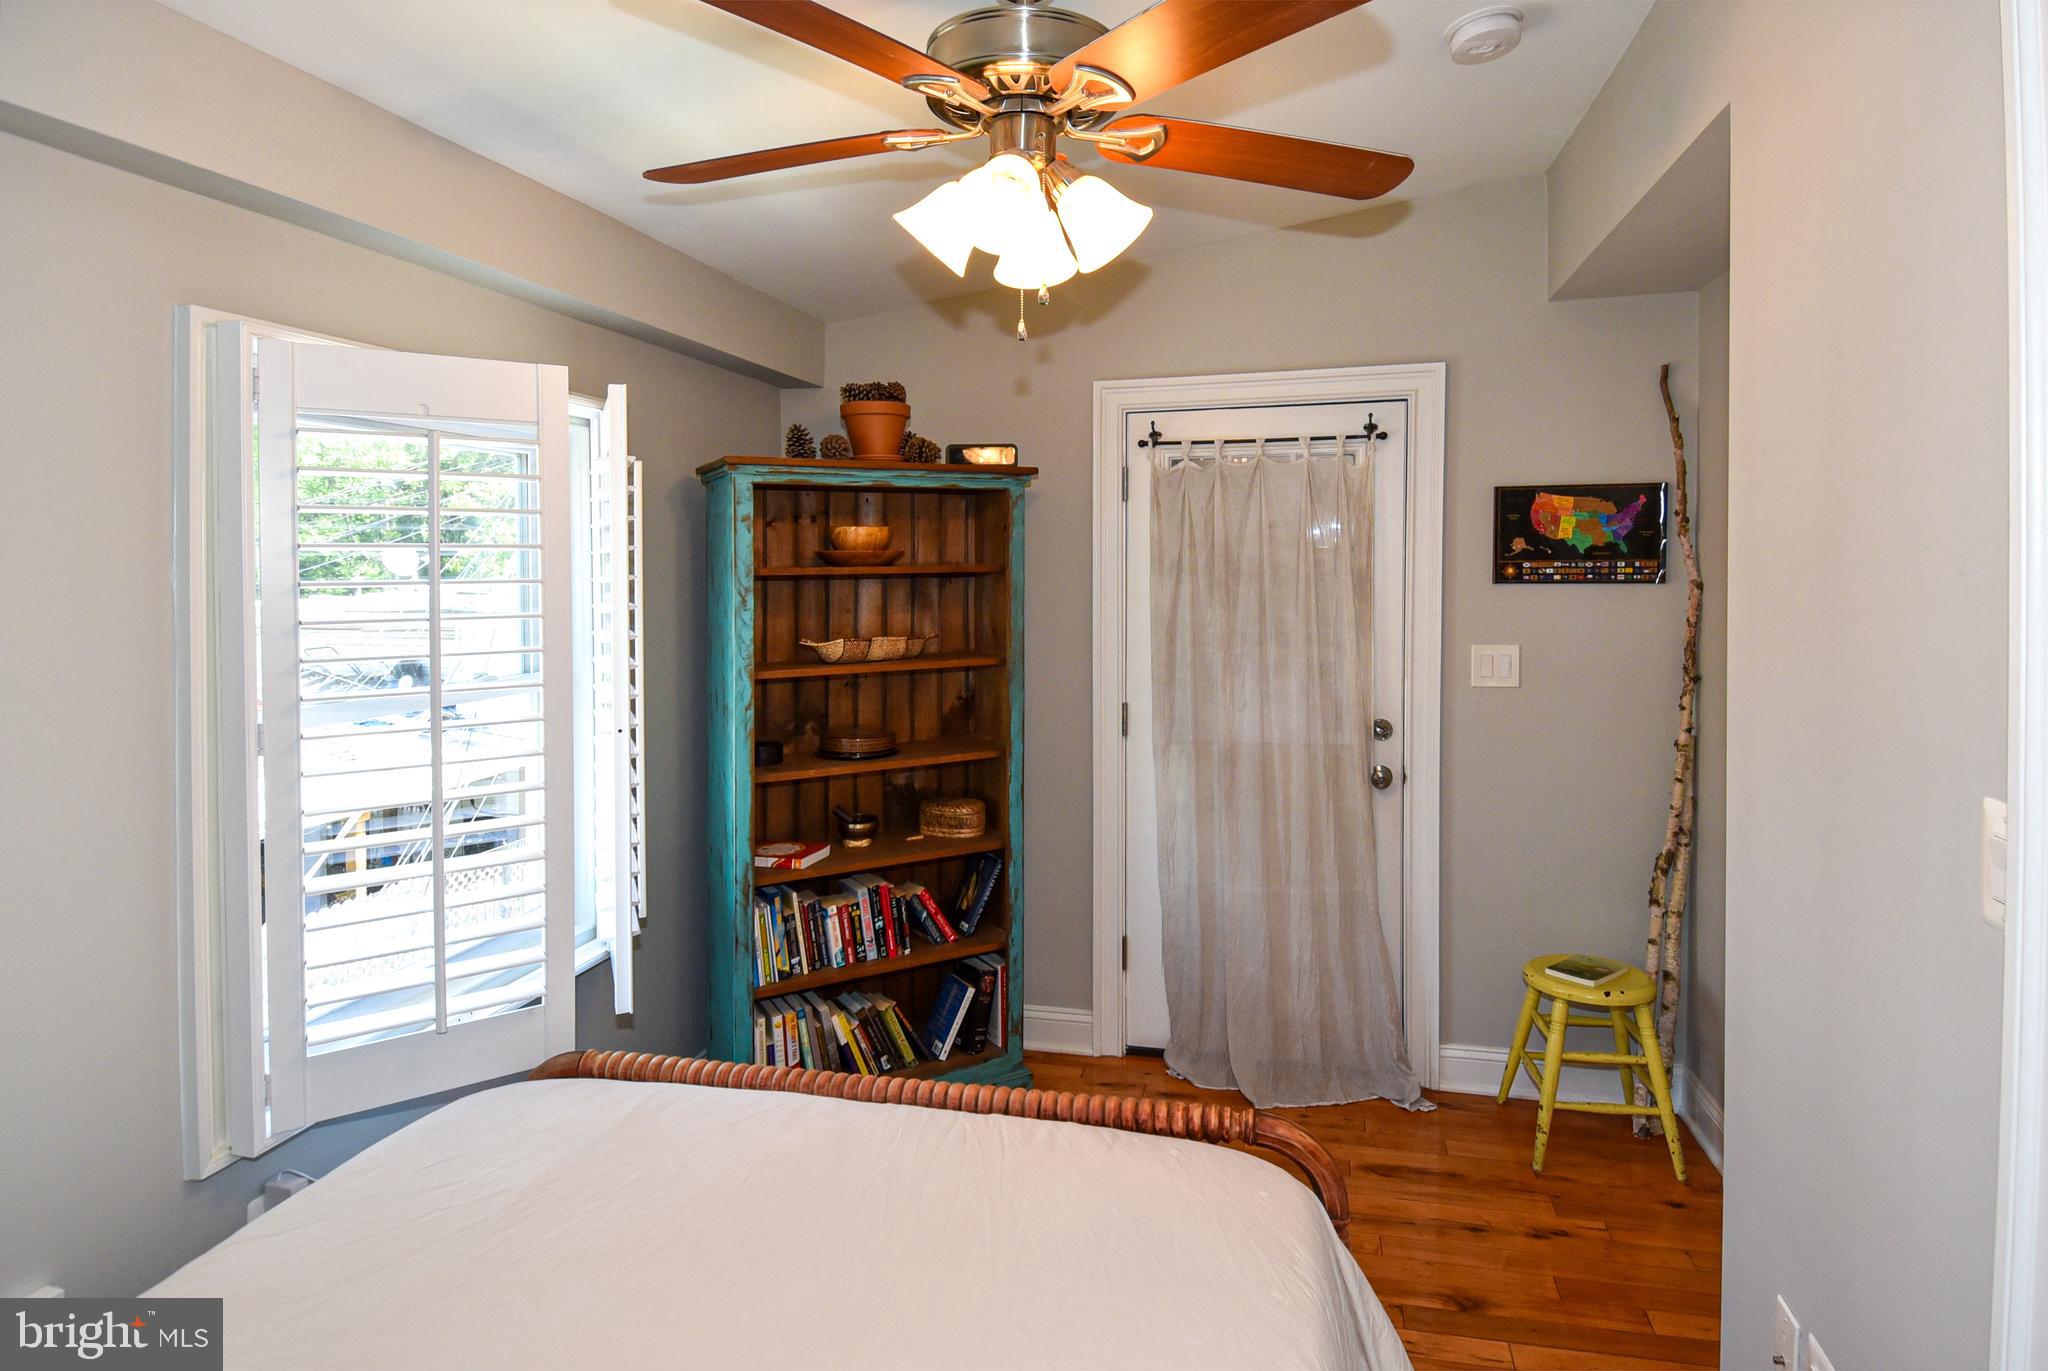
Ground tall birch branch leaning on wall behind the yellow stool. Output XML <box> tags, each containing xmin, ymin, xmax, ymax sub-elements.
<box><xmin>1634</xmin><ymin>363</ymin><xmax>1702</xmax><ymax>1137</ymax></box>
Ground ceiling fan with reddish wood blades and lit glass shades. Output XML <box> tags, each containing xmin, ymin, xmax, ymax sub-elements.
<box><xmin>645</xmin><ymin>0</ymin><xmax>1415</xmax><ymax>327</ymax></box>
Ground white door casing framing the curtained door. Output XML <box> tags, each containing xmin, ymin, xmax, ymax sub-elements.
<box><xmin>1094</xmin><ymin>363</ymin><xmax>1444</xmax><ymax>1086</ymax></box>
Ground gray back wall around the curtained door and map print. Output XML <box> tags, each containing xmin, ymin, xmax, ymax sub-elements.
<box><xmin>782</xmin><ymin>168</ymin><xmax>1698</xmax><ymax>1047</ymax></box>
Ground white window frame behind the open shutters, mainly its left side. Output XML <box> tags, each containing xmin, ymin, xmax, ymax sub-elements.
<box><xmin>172</xmin><ymin>305</ymin><xmax>637</xmax><ymax>1178</ymax></box>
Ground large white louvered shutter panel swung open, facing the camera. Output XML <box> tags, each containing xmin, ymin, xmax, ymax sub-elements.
<box><xmin>241</xmin><ymin>338</ymin><xmax>575</xmax><ymax>1154</ymax></box>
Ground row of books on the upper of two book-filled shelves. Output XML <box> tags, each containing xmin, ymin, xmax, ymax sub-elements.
<box><xmin>754</xmin><ymin>853</ymin><xmax>1004</xmax><ymax>986</ymax></box>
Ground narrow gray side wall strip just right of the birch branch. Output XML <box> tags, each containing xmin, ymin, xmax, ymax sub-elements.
<box><xmin>1679</xmin><ymin>277</ymin><xmax>1729</xmax><ymax>1105</ymax></box>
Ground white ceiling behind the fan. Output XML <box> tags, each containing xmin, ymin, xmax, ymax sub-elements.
<box><xmin>166</xmin><ymin>0</ymin><xmax>1651</xmax><ymax>320</ymax></box>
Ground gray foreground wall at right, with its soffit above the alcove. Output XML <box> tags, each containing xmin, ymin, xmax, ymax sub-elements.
<box><xmin>1548</xmin><ymin>0</ymin><xmax>2007</xmax><ymax>1369</ymax></box>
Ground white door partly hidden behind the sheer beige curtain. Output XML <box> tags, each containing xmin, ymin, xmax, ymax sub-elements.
<box><xmin>1124</xmin><ymin>400</ymin><xmax>1409</xmax><ymax>1049</ymax></box>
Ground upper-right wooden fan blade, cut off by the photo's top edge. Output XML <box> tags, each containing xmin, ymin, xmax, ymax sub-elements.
<box><xmin>1053</xmin><ymin>0</ymin><xmax>1366</xmax><ymax>102</ymax></box>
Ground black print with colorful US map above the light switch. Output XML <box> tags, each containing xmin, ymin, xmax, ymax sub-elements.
<box><xmin>1493</xmin><ymin>482</ymin><xmax>1665</xmax><ymax>586</ymax></box>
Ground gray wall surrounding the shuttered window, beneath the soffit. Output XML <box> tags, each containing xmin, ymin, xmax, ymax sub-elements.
<box><xmin>0</xmin><ymin>135</ymin><xmax>776</xmax><ymax>1293</ymax></box>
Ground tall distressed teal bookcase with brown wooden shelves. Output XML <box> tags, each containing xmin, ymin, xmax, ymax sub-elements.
<box><xmin>698</xmin><ymin>457</ymin><xmax>1036</xmax><ymax>1084</ymax></box>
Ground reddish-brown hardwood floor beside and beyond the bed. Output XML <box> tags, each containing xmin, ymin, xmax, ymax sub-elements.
<box><xmin>1024</xmin><ymin>1051</ymin><xmax>1720</xmax><ymax>1371</ymax></box>
